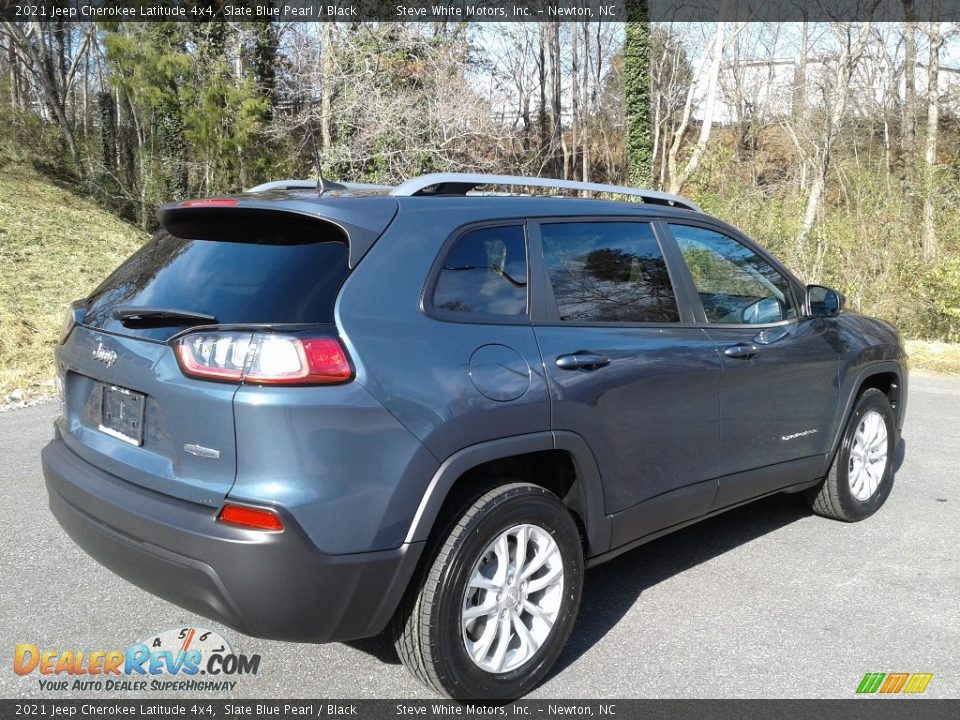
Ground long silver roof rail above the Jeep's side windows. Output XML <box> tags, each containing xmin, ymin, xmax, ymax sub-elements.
<box><xmin>390</xmin><ymin>173</ymin><xmax>703</xmax><ymax>212</ymax></box>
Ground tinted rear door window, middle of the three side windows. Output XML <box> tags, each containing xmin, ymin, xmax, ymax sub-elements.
<box><xmin>540</xmin><ymin>222</ymin><xmax>680</xmax><ymax>323</ymax></box>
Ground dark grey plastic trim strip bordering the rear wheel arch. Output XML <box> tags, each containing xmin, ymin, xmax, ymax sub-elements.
<box><xmin>404</xmin><ymin>431</ymin><xmax>610</xmax><ymax>557</ymax></box>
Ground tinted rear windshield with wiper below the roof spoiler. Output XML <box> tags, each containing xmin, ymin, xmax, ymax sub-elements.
<box><xmin>83</xmin><ymin>231</ymin><xmax>349</xmax><ymax>340</ymax></box>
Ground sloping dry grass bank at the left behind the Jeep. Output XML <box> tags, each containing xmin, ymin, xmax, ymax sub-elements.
<box><xmin>0</xmin><ymin>164</ymin><xmax>147</xmax><ymax>405</ymax></box>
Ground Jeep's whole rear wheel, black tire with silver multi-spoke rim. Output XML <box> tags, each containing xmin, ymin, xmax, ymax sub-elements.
<box><xmin>393</xmin><ymin>483</ymin><xmax>583</xmax><ymax>702</ymax></box>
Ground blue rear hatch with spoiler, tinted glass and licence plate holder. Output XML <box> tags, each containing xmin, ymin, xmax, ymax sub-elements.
<box><xmin>57</xmin><ymin>198</ymin><xmax>393</xmax><ymax>505</ymax></box>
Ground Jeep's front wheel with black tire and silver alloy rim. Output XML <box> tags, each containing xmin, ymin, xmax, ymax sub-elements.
<box><xmin>807</xmin><ymin>388</ymin><xmax>897</xmax><ymax>522</ymax></box>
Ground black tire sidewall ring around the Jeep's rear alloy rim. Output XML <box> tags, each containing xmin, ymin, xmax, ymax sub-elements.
<box><xmin>429</xmin><ymin>485</ymin><xmax>583</xmax><ymax>701</ymax></box>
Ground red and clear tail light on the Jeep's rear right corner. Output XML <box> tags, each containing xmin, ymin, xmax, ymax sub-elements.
<box><xmin>174</xmin><ymin>332</ymin><xmax>353</xmax><ymax>385</ymax></box>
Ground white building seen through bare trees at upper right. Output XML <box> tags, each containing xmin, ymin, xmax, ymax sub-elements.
<box><xmin>714</xmin><ymin>57</ymin><xmax>960</xmax><ymax>124</ymax></box>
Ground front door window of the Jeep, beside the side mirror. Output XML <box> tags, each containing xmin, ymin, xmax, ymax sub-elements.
<box><xmin>670</xmin><ymin>223</ymin><xmax>797</xmax><ymax>324</ymax></box>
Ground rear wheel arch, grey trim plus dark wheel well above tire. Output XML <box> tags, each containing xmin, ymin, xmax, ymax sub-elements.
<box><xmin>405</xmin><ymin>431</ymin><xmax>610</xmax><ymax>557</ymax></box>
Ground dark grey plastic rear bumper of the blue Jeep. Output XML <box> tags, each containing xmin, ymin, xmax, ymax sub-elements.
<box><xmin>42</xmin><ymin>437</ymin><xmax>423</xmax><ymax>642</ymax></box>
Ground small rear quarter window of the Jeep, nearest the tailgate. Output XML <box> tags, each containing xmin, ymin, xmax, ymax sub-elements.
<box><xmin>433</xmin><ymin>225</ymin><xmax>527</xmax><ymax>316</ymax></box>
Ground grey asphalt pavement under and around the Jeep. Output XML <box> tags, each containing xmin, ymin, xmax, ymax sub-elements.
<box><xmin>0</xmin><ymin>374</ymin><xmax>960</xmax><ymax>699</ymax></box>
